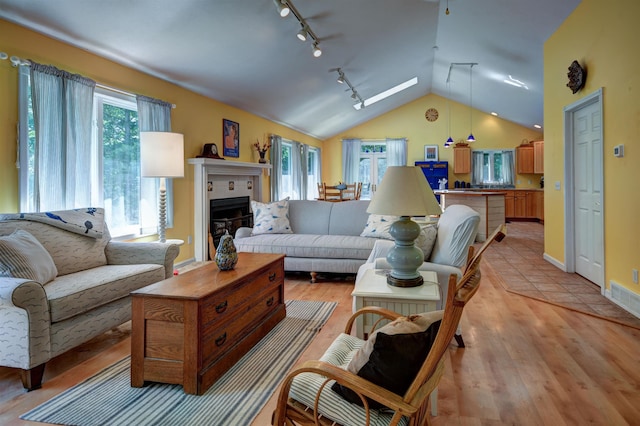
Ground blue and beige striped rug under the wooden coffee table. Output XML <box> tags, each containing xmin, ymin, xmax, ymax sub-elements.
<box><xmin>20</xmin><ymin>300</ymin><xmax>336</xmax><ymax>426</ymax></box>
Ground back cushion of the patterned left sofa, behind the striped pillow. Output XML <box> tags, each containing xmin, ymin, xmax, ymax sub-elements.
<box><xmin>0</xmin><ymin>220</ymin><xmax>111</xmax><ymax>277</ymax></box>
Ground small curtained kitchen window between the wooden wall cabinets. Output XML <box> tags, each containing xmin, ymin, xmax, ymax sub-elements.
<box><xmin>471</xmin><ymin>150</ymin><xmax>514</xmax><ymax>186</ymax></box>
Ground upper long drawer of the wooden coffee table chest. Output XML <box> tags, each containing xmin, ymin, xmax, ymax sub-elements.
<box><xmin>202</xmin><ymin>267</ymin><xmax>284</xmax><ymax>327</ymax></box>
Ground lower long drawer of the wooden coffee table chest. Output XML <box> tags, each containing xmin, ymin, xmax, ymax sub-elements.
<box><xmin>202</xmin><ymin>287</ymin><xmax>284</xmax><ymax>366</ymax></box>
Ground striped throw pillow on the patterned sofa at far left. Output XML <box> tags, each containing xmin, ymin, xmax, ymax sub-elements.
<box><xmin>0</xmin><ymin>229</ymin><xmax>58</xmax><ymax>284</ymax></box>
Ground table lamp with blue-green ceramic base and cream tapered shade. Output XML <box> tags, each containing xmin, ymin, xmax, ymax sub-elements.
<box><xmin>367</xmin><ymin>166</ymin><xmax>442</xmax><ymax>287</ymax></box>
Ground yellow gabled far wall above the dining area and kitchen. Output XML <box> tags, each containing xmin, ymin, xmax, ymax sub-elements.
<box><xmin>322</xmin><ymin>95</ymin><xmax>546</xmax><ymax>188</ymax></box>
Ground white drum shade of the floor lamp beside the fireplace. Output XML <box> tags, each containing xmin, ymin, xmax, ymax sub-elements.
<box><xmin>140</xmin><ymin>132</ymin><xmax>184</xmax><ymax>177</ymax></box>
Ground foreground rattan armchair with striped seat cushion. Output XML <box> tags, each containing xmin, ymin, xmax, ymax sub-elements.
<box><xmin>272</xmin><ymin>255</ymin><xmax>481</xmax><ymax>426</ymax></box>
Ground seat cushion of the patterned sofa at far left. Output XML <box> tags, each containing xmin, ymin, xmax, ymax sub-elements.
<box><xmin>45</xmin><ymin>264</ymin><xmax>164</xmax><ymax>322</ymax></box>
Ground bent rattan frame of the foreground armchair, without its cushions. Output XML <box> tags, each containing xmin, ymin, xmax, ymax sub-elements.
<box><xmin>272</xmin><ymin>253</ymin><xmax>482</xmax><ymax>426</ymax></box>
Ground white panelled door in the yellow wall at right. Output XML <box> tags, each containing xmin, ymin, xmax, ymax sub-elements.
<box><xmin>573</xmin><ymin>102</ymin><xmax>604</xmax><ymax>288</ymax></box>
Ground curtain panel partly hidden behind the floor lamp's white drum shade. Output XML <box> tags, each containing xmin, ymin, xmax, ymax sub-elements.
<box><xmin>136</xmin><ymin>95</ymin><xmax>174</xmax><ymax>229</ymax></box>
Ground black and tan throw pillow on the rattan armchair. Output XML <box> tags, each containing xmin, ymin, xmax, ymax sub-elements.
<box><xmin>331</xmin><ymin>311</ymin><xmax>443</xmax><ymax>408</ymax></box>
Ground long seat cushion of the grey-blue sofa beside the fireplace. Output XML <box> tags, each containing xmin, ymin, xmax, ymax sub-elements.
<box><xmin>234</xmin><ymin>234</ymin><xmax>375</xmax><ymax>260</ymax></box>
